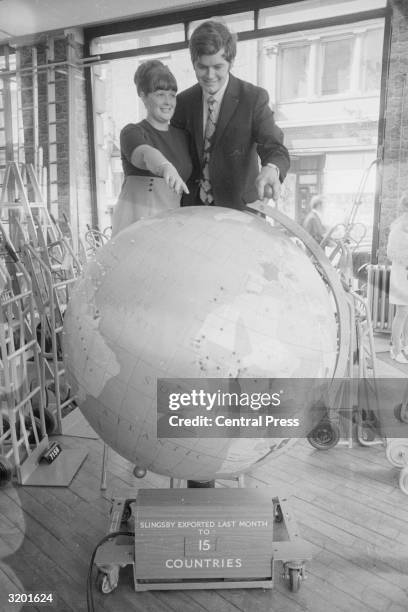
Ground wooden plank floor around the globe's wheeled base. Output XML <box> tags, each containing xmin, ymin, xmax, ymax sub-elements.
<box><xmin>0</xmin><ymin>420</ymin><xmax>408</xmax><ymax>612</ymax></box>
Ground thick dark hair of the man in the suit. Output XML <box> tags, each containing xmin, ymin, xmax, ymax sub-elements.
<box><xmin>190</xmin><ymin>21</ymin><xmax>237</xmax><ymax>64</ymax></box>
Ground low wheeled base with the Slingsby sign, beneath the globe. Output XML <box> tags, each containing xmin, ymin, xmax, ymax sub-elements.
<box><xmin>95</xmin><ymin>487</ymin><xmax>312</xmax><ymax>594</ymax></box>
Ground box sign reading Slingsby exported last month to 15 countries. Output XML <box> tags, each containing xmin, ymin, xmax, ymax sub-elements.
<box><xmin>132</xmin><ymin>488</ymin><xmax>274</xmax><ymax>588</ymax></box>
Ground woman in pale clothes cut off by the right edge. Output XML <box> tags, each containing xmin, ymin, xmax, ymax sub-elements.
<box><xmin>387</xmin><ymin>194</ymin><xmax>408</xmax><ymax>363</ymax></box>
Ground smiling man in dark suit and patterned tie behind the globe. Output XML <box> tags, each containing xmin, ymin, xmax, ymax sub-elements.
<box><xmin>172</xmin><ymin>21</ymin><xmax>290</xmax><ymax>210</ymax></box>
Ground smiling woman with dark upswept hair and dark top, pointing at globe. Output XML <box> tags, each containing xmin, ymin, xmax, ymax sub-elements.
<box><xmin>112</xmin><ymin>60</ymin><xmax>192</xmax><ymax>236</ymax></box>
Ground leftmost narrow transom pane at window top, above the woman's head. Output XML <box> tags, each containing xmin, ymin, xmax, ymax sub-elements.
<box><xmin>91</xmin><ymin>23</ymin><xmax>184</xmax><ymax>54</ymax></box>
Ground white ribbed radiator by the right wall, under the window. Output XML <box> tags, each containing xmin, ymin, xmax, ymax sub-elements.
<box><xmin>367</xmin><ymin>264</ymin><xmax>395</xmax><ymax>333</ymax></box>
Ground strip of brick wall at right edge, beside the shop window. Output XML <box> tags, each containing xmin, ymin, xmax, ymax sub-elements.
<box><xmin>379</xmin><ymin>0</ymin><xmax>408</xmax><ymax>263</ymax></box>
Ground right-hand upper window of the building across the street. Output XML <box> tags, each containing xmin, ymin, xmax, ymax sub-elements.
<box><xmin>321</xmin><ymin>39</ymin><xmax>353</xmax><ymax>95</ymax></box>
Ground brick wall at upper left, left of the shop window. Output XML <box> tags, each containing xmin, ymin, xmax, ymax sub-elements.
<box><xmin>19</xmin><ymin>32</ymin><xmax>92</xmax><ymax>235</ymax></box>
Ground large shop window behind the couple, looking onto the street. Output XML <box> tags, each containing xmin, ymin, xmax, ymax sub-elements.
<box><xmin>87</xmin><ymin>0</ymin><xmax>386</xmax><ymax>239</ymax></box>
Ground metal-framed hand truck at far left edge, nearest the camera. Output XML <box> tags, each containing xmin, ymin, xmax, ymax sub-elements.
<box><xmin>0</xmin><ymin>248</ymin><xmax>49</xmax><ymax>484</ymax></box>
